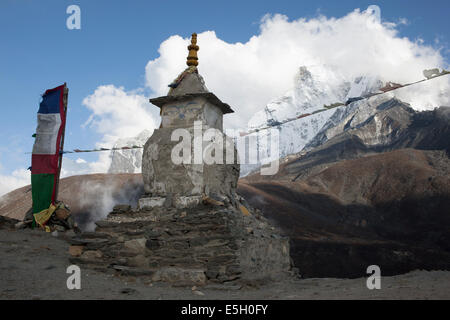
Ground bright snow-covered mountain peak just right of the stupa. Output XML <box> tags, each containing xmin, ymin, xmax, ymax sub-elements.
<box><xmin>241</xmin><ymin>66</ymin><xmax>382</xmax><ymax>175</ymax></box>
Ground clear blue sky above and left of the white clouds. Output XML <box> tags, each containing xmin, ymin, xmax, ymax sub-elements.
<box><xmin>0</xmin><ymin>0</ymin><xmax>450</xmax><ymax>194</ymax></box>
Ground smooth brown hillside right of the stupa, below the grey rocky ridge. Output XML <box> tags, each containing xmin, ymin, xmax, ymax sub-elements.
<box><xmin>239</xmin><ymin>149</ymin><xmax>450</xmax><ymax>277</ymax></box>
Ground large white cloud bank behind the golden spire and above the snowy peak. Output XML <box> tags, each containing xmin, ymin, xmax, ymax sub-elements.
<box><xmin>146</xmin><ymin>10</ymin><xmax>450</xmax><ymax>127</ymax></box>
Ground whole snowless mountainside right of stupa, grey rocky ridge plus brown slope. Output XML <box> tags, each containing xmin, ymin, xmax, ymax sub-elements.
<box><xmin>239</xmin><ymin>98</ymin><xmax>450</xmax><ymax>277</ymax></box>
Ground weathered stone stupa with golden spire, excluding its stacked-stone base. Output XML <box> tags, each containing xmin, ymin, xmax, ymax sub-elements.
<box><xmin>139</xmin><ymin>33</ymin><xmax>239</xmax><ymax>208</ymax></box>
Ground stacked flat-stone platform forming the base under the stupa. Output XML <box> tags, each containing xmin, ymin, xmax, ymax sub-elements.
<box><xmin>69</xmin><ymin>198</ymin><xmax>292</xmax><ymax>285</ymax></box>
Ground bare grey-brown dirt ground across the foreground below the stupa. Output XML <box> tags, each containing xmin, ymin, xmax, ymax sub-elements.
<box><xmin>0</xmin><ymin>228</ymin><xmax>450</xmax><ymax>300</ymax></box>
